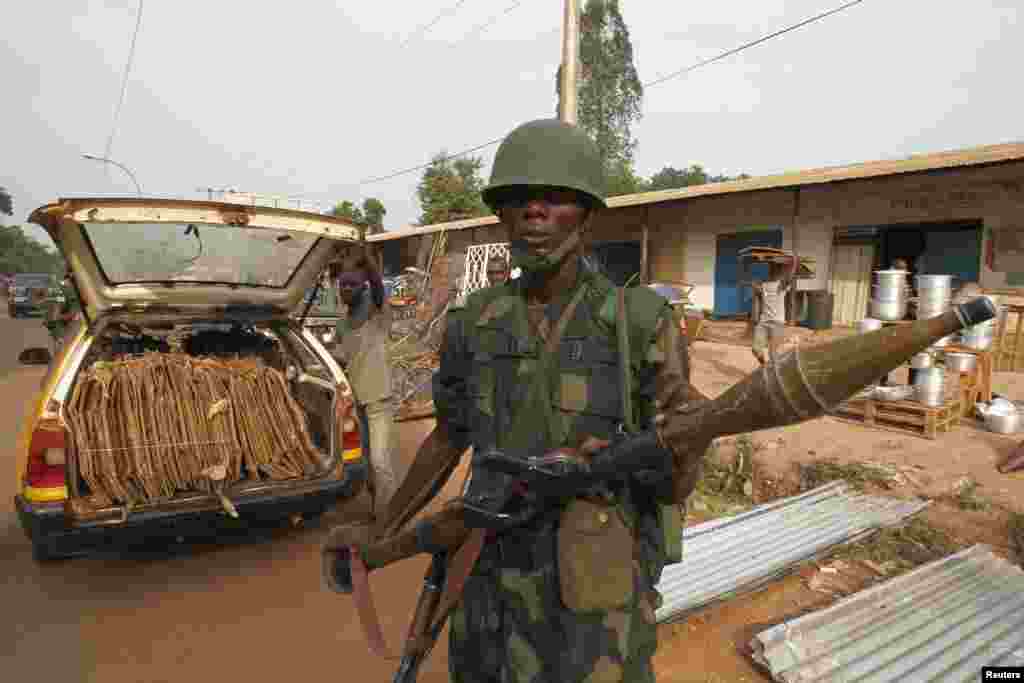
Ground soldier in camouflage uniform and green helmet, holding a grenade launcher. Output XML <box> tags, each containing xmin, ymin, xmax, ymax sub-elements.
<box><xmin>325</xmin><ymin>120</ymin><xmax>706</xmax><ymax>683</ymax></box>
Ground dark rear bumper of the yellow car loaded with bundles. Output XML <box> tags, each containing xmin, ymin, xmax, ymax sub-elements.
<box><xmin>14</xmin><ymin>463</ymin><xmax>367</xmax><ymax>553</ymax></box>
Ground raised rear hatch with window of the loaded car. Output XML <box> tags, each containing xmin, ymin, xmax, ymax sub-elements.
<box><xmin>29</xmin><ymin>198</ymin><xmax>359</xmax><ymax>317</ymax></box>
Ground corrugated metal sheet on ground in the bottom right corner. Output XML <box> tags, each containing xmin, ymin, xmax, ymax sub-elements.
<box><xmin>752</xmin><ymin>545</ymin><xmax>1024</xmax><ymax>683</ymax></box>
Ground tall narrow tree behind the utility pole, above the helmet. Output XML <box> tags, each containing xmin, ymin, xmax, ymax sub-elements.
<box><xmin>555</xmin><ymin>0</ymin><xmax>643</xmax><ymax>196</ymax></box>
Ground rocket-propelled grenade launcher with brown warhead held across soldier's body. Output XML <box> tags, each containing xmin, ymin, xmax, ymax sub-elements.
<box><xmin>342</xmin><ymin>297</ymin><xmax>996</xmax><ymax>568</ymax></box>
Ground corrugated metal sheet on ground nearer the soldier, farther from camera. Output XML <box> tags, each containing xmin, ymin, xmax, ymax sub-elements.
<box><xmin>656</xmin><ymin>481</ymin><xmax>928</xmax><ymax>622</ymax></box>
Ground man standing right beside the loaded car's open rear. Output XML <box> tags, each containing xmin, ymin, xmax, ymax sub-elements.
<box><xmin>333</xmin><ymin>243</ymin><xmax>397</xmax><ymax>515</ymax></box>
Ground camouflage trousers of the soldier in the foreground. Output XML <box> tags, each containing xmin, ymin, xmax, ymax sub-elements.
<box><xmin>449</xmin><ymin>543</ymin><xmax>657</xmax><ymax>683</ymax></box>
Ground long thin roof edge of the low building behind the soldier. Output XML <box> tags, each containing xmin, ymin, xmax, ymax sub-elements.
<box><xmin>367</xmin><ymin>142</ymin><xmax>1024</xmax><ymax>242</ymax></box>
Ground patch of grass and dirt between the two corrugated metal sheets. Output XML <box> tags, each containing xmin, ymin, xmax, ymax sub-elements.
<box><xmin>834</xmin><ymin>517</ymin><xmax>962</xmax><ymax>575</ymax></box>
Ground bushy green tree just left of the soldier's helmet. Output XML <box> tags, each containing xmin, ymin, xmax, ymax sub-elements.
<box><xmin>416</xmin><ymin>152</ymin><xmax>490</xmax><ymax>225</ymax></box>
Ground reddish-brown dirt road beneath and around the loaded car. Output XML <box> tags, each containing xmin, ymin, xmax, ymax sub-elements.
<box><xmin>0</xmin><ymin>316</ymin><xmax>456</xmax><ymax>683</ymax></box>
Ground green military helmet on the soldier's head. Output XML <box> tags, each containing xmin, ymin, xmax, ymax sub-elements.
<box><xmin>483</xmin><ymin>119</ymin><xmax>606</xmax><ymax>210</ymax></box>
